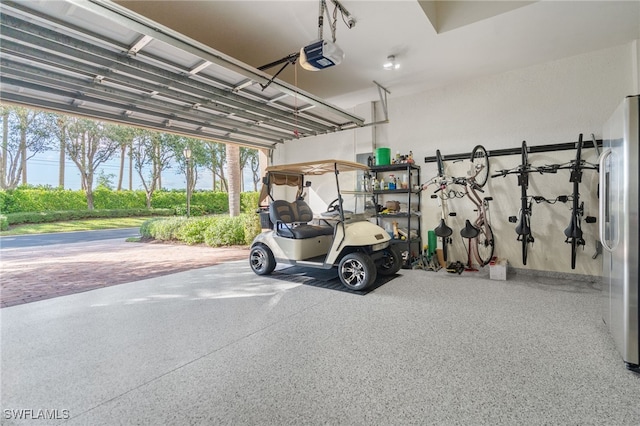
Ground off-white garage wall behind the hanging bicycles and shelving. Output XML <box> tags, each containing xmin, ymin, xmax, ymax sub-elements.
<box><xmin>274</xmin><ymin>42</ymin><xmax>640</xmax><ymax>275</ymax></box>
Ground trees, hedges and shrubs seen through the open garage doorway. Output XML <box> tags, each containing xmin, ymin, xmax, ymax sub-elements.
<box><xmin>0</xmin><ymin>105</ymin><xmax>260</xmax><ymax>246</ymax></box>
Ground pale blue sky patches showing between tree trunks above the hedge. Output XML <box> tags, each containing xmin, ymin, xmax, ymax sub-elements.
<box><xmin>27</xmin><ymin>151</ymin><xmax>253</xmax><ymax>190</ymax></box>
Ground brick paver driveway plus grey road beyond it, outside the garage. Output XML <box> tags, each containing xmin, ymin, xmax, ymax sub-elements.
<box><xmin>0</xmin><ymin>230</ymin><xmax>249</xmax><ymax>308</ymax></box>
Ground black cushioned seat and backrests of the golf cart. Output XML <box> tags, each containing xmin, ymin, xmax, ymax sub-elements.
<box><xmin>269</xmin><ymin>200</ymin><xmax>333</xmax><ymax>239</ymax></box>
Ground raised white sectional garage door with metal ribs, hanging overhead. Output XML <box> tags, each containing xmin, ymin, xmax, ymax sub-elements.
<box><xmin>0</xmin><ymin>0</ymin><xmax>363</xmax><ymax>148</ymax></box>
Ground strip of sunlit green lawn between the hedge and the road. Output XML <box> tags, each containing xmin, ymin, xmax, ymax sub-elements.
<box><xmin>0</xmin><ymin>217</ymin><xmax>150</xmax><ymax>237</ymax></box>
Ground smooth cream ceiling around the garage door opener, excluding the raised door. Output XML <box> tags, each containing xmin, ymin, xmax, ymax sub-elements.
<box><xmin>117</xmin><ymin>0</ymin><xmax>640</xmax><ymax>108</ymax></box>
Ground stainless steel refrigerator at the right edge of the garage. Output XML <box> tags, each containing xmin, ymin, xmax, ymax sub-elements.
<box><xmin>599</xmin><ymin>95</ymin><xmax>640</xmax><ymax>372</ymax></box>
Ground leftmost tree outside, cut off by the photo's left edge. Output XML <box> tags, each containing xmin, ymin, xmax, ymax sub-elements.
<box><xmin>0</xmin><ymin>105</ymin><xmax>56</xmax><ymax>189</ymax></box>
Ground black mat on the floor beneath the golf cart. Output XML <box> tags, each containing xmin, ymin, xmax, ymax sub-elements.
<box><xmin>271</xmin><ymin>266</ymin><xmax>397</xmax><ymax>296</ymax></box>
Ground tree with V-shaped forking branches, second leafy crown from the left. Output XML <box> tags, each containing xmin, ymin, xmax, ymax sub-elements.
<box><xmin>66</xmin><ymin>117</ymin><xmax>118</xmax><ymax>210</ymax></box>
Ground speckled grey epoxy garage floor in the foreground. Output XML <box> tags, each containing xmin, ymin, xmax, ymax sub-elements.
<box><xmin>0</xmin><ymin>261</ymin><xmax>640</xmax><ymax>425</ymax></box>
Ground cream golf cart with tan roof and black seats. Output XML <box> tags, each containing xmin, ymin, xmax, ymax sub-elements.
<box><xmin>249</xmin><ymin>160</ymin><xmax>402</xmax><ymax>290</ymax></box>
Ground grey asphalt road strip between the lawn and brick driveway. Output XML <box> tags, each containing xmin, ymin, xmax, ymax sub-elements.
<box><xmin>0</xmin><ymin>228</ymin><xmax>140</xmax><ymax>249</ymax></box>
